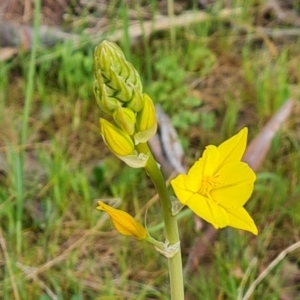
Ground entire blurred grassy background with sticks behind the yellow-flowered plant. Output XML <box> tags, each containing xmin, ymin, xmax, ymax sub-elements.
<box><xmin>0</xmin><ymin>0</ymin><xmax>300</xmax><ymax>300</ymax></box>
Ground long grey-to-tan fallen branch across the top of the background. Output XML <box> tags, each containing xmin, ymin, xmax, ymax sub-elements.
<box><xmin>0</xmin><ymin>8</ymin><xmax>242</xmax><ymax>49</ymax></box>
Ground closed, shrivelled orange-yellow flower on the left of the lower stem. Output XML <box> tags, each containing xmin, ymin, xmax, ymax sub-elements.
<box><xmin>97</xmin><ymin>201</ymin><xmax>148</xmax><ymax>240</ymax></box>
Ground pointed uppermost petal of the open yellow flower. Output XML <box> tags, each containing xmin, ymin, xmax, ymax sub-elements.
<box><xmin>218</xmin><ymin>127</ymin><xmax>248</xmax><ymax>170</ymax></box>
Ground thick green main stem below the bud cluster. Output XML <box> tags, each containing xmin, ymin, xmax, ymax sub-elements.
<box><xmin>136</xmin><ymin>144</ymin><xmax>184</xmax><ymax>300</ymax></box>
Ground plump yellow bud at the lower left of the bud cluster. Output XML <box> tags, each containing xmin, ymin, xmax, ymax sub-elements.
<box><xmin>100</xmin><ymin>118</ymin><xmax>134</xmax><ymax>156</ymax></box>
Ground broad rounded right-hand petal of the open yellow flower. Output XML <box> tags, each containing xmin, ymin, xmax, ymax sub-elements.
<box><xmin>210</xmin><ymin>162</ymin><xmax>256</xmax><ymax>208</ymax></box>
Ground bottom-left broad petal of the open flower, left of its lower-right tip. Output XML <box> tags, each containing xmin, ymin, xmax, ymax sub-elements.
<box><xmin>186</xmin><ymin>194</ymin><xmax>230</xmax><ymax>229</ymax></box>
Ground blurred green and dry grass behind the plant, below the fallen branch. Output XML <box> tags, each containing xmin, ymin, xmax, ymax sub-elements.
<box><xmin>0</xmin><ymin>1</ymin><xmax>300</xmax><ymax>300</ymax></box>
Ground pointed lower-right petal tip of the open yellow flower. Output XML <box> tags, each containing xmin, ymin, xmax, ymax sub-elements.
<box><xmin>226</xmin><ymin>208</ymin><xmax>258</xmax><ymax>235</ymax></box>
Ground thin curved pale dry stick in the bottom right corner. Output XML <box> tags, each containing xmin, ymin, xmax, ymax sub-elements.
<box><xmin>238</xmin><ymin>242</ymin><xmax>300</xmax><ymax>300</ymax></box>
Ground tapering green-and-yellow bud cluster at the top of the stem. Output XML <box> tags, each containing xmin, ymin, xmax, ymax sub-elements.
<box><xmin>94</xmin><ymin>41</ymin><xmax>157</xmax><ymax>167</ymax></box>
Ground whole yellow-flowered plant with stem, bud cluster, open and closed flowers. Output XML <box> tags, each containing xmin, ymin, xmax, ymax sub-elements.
<box><xmin>94</xmin><ymin>41</ymin><xmax>258</xmax><ymax>300</ymax></box>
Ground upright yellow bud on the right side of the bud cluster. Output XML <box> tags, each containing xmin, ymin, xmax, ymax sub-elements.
<box><xmin>134</xmin><ymin>94</ymin><xmax>157</xmax><ymax>145</ymax></box>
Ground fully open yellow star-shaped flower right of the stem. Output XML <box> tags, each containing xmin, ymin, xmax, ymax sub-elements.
<box><xmin>171</xmin><ymin>128</ymin><xmax>258</xmax><ymax>234</ymax></box>
